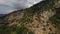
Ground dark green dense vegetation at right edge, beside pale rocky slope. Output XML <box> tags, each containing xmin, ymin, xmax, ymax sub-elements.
<box><xmin>50</xmin><ymin>8</ymin><xmax>60</xmax><ymax>28</ymax></box>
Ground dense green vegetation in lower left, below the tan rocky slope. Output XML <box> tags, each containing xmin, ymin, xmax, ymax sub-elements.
<box><xmin>0</xmin><ymin>24</ymin><xmax>34</xmax><ymax>34</ymax></box>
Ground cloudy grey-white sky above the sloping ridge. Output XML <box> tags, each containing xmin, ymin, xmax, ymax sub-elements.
<box><xmin>0</xmin><ymin>0</ymin><xmax>42</xmax><ymax>14</ymax></box>
